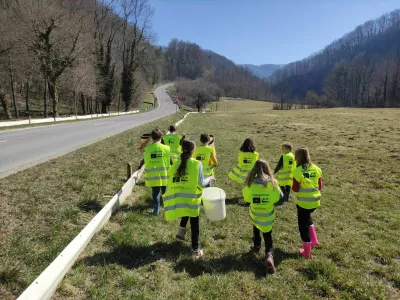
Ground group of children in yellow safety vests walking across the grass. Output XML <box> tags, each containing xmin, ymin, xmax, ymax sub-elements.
<box><xmin>142</xmin><ymin>125</ymin><xmax>322</xmax><ymax>273</ymax></box>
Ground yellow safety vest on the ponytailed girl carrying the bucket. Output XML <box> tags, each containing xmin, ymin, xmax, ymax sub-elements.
<box><xmin>163</xmin><ymin>158</ymin><xmax>203</xmax><ymax>221</ymax></box>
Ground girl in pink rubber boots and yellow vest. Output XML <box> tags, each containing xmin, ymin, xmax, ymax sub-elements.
<box><xmin>293</xmin><ymin>147</ymin><xmax>322</xmax><ymax>259</ymax></box>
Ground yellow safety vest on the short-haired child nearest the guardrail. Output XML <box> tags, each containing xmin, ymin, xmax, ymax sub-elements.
<box><xmin>144</xmin><ymin>143</ymin><xmax>170</xmax><ymax>187</ymax></box>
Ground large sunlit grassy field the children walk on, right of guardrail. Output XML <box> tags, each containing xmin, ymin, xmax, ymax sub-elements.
<box><xmin>43</xmin><ymin>101</ymin><xmax>400</xmax><ymax>299</ymax></box>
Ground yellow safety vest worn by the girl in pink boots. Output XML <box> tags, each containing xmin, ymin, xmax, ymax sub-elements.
<box><xmin>293</xmin><ymin>164</ymin><xmax>322</xmax><ymax>209</ymax></box>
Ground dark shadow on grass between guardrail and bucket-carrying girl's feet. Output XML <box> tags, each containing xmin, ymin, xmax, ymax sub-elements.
<box><xmin>83</xmin><ymin>242</ymin><xmax>191</xmax><ymax>269</ymax></box>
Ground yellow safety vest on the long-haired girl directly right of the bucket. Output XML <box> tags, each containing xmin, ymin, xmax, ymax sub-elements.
<box><xmin>243</xmin><ymin>180</ymin><xmax>281</xmax><ymax>232</ymax></box>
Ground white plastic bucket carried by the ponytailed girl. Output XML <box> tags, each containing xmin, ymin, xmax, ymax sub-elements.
<box><xmin>202</xmin><ymin>187</ymin><xmax>226</xmax><ymax>221</ymax></box>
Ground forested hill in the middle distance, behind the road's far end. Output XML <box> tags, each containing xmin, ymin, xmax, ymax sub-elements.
<box><xmin>164</xmin><ymin>39</ymin><xmax>269</xmax><ymax>100</ymax></box>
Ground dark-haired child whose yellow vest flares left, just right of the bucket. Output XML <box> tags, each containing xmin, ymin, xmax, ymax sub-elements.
<box><xmin>228</xmin><ymin>138</ymin><xmax>259</xmax><ymax>183</ymax></box>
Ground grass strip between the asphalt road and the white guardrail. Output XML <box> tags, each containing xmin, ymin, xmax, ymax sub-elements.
<box><xmin>0</xmin><ymin>112</ymin><xmax>185</xmax><ymax>299</ymax></box>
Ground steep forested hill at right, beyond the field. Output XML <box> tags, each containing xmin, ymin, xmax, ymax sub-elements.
<box><xmin>273</xmin><ymin>10</ymin><xmax>400</xmax><ymax>106</ymax></box>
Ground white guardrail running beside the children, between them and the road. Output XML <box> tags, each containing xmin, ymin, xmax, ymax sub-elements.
<box><xmin>18</xmin><ymin>113</ymin><xmax>195</xmax><ymax>300</ymax></box>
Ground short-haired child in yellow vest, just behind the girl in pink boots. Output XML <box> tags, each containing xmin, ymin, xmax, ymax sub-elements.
<box><xmin>274</xmin><ymin>143</ymin><xmax>296</xmax><ymax>201</ymax></box>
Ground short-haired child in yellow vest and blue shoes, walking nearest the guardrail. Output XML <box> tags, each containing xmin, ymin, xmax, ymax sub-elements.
<box><xmin>144</xmin><ymin>129</ymin><xmax>170</xmax><ymax>215</ymax></box>
